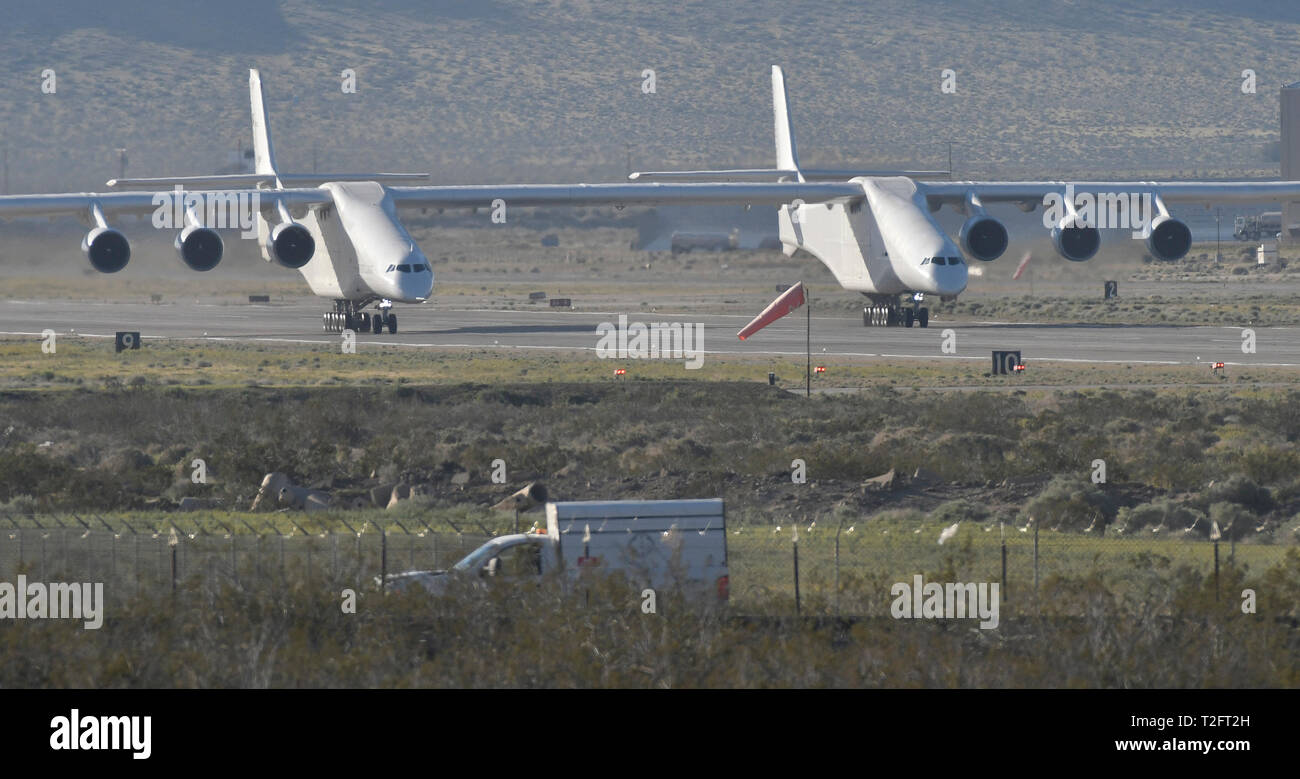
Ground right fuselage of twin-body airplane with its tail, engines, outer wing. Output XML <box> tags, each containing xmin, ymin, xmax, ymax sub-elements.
<box><xmin>629</xmin><ymin>66</ymin><xmax>1300</xmax><ymax>328</ymax></box>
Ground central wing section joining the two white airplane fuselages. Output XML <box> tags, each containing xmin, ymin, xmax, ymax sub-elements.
<box><xmin>389</xmin><ymin>181</ymin><xmax>865</xmax><ymax>208</ymax></box>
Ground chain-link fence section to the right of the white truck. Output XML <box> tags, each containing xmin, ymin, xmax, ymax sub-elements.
<box><xmin>728</xmin><ymin>522</ymin><xmax>1300</xmax><ymax>616</ymax></box>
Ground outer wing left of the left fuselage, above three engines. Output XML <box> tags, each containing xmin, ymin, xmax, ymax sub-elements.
<box><xmin>0</xmin><ymin>189</ymin><xmax>333</xmax><ymax>218</ymax></box>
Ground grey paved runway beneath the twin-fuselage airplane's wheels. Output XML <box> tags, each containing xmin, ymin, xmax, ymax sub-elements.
<box><xmin>0</xmin><ymin>298</ymin><xmax>1300</xmax><ymax>367</ymax></box>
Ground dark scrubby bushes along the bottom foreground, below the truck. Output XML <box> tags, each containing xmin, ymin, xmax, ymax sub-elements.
<box><xmin>0</xmin><ymin>561</ymin><xmax>1300</xmax><ymax>688</ymax></box>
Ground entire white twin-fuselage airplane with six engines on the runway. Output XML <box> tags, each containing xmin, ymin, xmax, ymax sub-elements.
<box><xmin>0</xmin><ymin>66</ymin><xmax>1300</xmax><ymax>334</ymax></box>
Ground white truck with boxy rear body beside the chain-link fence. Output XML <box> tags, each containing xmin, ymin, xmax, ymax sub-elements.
<box><xmin>385</xmin><ymin>498</ymin><xmax>731</xmax><ymax>601</ymax></box>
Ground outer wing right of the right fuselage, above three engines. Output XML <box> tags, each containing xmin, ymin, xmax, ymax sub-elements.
<box><xmin>917</xmin><ymin>181</ymin><xmax>1300</xmax><ymax>208</ymax></box>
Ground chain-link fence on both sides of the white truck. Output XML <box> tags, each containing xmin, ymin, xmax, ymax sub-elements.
<box><xmin>0</xmin><ymin>514</ymin><xmax>1300</xmax><ymax>616</ymax></box>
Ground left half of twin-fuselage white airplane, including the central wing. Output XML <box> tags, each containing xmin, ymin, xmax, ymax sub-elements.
<box><xmin>0</xmin><ymin>70</ymin><xmax>861</xmax><ymax>334</ymax></box>
